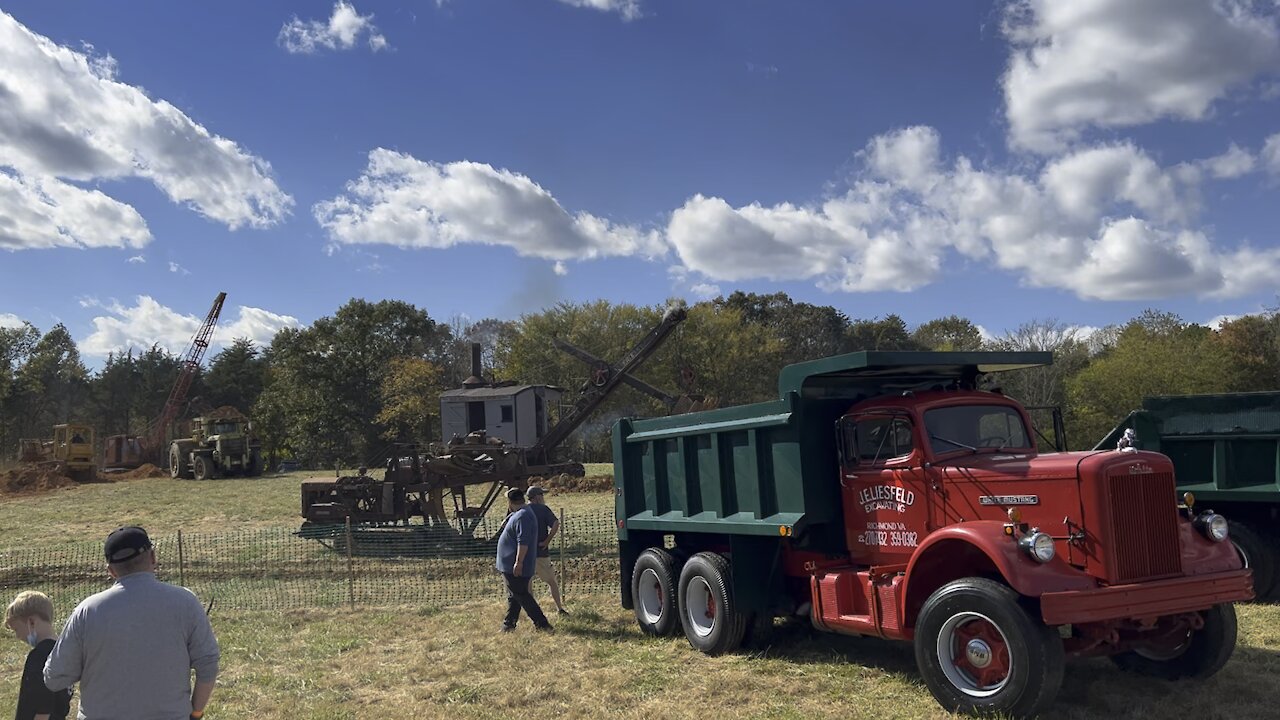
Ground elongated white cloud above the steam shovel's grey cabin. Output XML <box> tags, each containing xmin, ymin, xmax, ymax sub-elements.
<box><xmin>312</xmin><ymin>149</ymin><xmax>666</xmax><ymax>260</ymax></box>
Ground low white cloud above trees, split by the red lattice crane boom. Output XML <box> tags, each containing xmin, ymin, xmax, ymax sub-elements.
<box><xmin>79</xmin><ymin>295</ymin><xmax>301</xmax><ymax>357</ymax></box>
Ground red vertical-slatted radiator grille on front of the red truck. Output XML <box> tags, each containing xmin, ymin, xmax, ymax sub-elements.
<box><xmin>1106</xmin><ymin>473</ymin><xmax>1183</xmax><ymax>583</ymax></box>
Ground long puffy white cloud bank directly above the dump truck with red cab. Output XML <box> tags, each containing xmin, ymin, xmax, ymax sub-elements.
<box><xmin>667</xmin><ymin>128</ymin><xmax>1280</xmax><ymax>300</ymax></box>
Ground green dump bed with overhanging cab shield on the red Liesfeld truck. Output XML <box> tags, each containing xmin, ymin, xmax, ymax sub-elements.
<box><xmin>613</xmin><ymin>352</ymin><xmax>1052</xmax><ymax>541</ymax></box>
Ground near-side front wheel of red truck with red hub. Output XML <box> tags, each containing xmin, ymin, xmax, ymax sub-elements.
<box><xmin>915</xmin><ymin>578</ymin><xmax>1065</xmax><ymax>717</ymax></box>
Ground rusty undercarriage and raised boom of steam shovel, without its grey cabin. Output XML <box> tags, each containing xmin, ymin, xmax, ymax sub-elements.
<box><xmin>298</xmin><ymin>299</ymin><xmax>687</xmax><ymax>544</ymax></box>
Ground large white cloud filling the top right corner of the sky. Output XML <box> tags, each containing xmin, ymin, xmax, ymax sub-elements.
<box><xmin>1002</xmin><ymin>0</ymin><xmax>1280</xmax><ymax>152</ymax></box>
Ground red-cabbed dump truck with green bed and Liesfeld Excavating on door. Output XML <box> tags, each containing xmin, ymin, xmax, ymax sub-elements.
<box><xmin>613</xmin><ymin>352</ymin><xmax>1253</xmax><ymax>716</ymax></box>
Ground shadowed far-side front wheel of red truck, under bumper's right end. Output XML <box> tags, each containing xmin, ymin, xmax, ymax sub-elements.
<box><xmin>1111</xmin><ymin>605</ymin><xmax>1235</xmax><ymax>680</ymax></box>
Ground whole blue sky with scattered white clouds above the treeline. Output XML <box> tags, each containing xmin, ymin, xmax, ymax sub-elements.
<box><xmin>0</xmin><ymin>0</ymin><xmax>1280</xmax><ymax>363</ymax></box>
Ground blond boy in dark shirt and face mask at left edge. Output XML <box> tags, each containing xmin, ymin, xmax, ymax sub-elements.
<box><xmin>4</xmin><ymin>591</ymin><xmax>72</xmax><ymax>720</ymax></box>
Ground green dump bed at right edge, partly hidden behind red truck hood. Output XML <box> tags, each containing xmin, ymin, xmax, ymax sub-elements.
<box><xmin>1097</xmin><ymin>392</ymin><xmax>1280</xmax><ymax>502</ymax></box>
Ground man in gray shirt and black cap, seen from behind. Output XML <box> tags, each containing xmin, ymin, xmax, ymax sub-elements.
<box><xmin>45</xmin><ymin>527</ymin><xmax>219</xmax><ymax>720</ymax></box>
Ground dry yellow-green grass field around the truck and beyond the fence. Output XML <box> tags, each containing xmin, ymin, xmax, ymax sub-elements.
<box><xmin>0</xmin><ymin>466</ymin><xmax>1280</xmax><ymax>720</ymax></box>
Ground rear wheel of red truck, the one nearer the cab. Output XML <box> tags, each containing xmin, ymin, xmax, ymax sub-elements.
<box><xmin>680</xmin><ymin>552</ymin><xmax>746</xmax><ymax>655</ymax></box>
